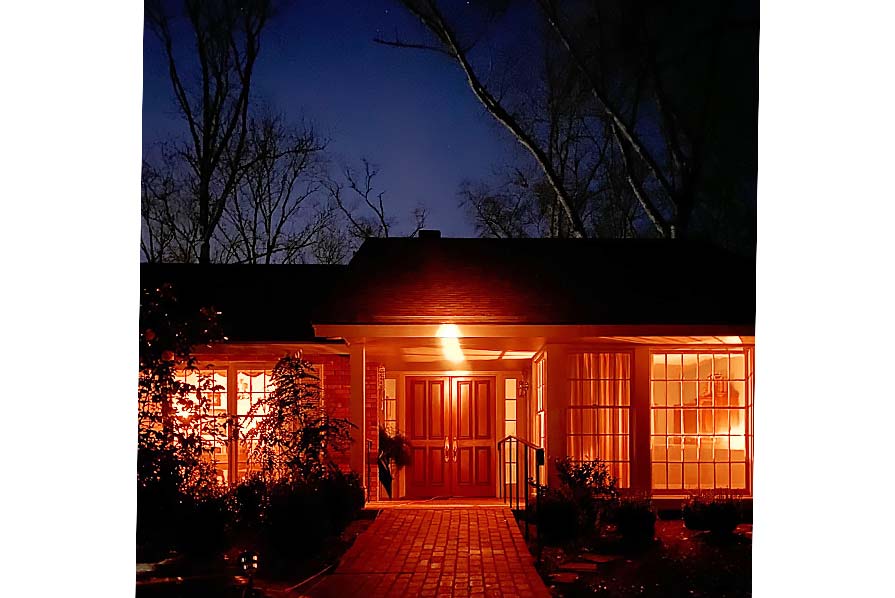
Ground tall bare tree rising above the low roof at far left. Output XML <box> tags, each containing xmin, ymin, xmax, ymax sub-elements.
<box><xmin>146</xmin><ymin>0</ymin><xmax>271</xmax><ymax>263</ymax></box>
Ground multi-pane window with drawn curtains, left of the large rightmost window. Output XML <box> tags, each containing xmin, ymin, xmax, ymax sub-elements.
<box><xmin>566</xmin><ymin>353</ymin><xmax>631</xmax><ymax>488</ymax></box>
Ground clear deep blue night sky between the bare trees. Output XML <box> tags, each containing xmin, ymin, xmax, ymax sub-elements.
<box><xmin>143</xmin><ymin>0</ymin><xmax>519</xmax><ymax>236</ymax></box>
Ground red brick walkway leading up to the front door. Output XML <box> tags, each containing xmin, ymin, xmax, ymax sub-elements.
<box><xmin>306</xmin><ymin>507</ymin><xmax>550</xmax><ymax>598</ymax></box>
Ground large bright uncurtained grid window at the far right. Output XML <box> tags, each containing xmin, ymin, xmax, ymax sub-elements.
<box><xmin>650</xmin><ymin>349</ymin><xmax>752</xmax><ymax>491</ymax></box>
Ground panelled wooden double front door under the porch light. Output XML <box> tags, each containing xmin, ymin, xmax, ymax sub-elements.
<box><xmin>405</xmin><ymin>376</ymin><xmax>496</xmax><ymax>498</ymax></box>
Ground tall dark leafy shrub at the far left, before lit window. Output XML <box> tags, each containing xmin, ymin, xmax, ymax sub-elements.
<box><xmin>137</xmin><ymin>284</ymin><xmax>226</xmax><ymax>558</ymax></box>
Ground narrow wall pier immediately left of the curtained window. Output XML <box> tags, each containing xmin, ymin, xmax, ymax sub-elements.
<box><xmin>544</xmin><ymin>345</ymin><xmax>569</xmax><ymax>487</ymax></box>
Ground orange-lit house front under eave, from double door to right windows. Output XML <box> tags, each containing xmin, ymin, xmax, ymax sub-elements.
<box><xmin>338</xmin><ymin>325</ymin><xmax>754</xmax><ymax>504</ymax></box>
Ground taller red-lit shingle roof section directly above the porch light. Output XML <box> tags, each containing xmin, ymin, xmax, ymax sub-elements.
<box><xmin>314</xmin><ymin>238</ymin><xmax>755</xmax><ymax>326</ymax></box>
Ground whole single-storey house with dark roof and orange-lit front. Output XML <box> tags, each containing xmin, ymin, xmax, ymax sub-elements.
<box><xmin>141</xmin><ymin>237</ymin><xmax>755</xmax><ymax>500</ymax></box>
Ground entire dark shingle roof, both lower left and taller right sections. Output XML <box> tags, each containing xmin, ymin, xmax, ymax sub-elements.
<box><xmin>140</xmin><ymin>238</ymin><xmax>755</xmax><ymax>341</ymax></box>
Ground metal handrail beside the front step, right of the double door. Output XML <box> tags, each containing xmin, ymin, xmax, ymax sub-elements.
<box><xmin>497</xmin><ymin>436</ymin><xmax>544</xmax><ymax>539</ymax></box>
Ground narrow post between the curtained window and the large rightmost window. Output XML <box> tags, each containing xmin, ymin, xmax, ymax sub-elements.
<box><xmin>631</xmin><ymin>347</ymin><xmax>652</xmax><ymax>492</ymax></box>
